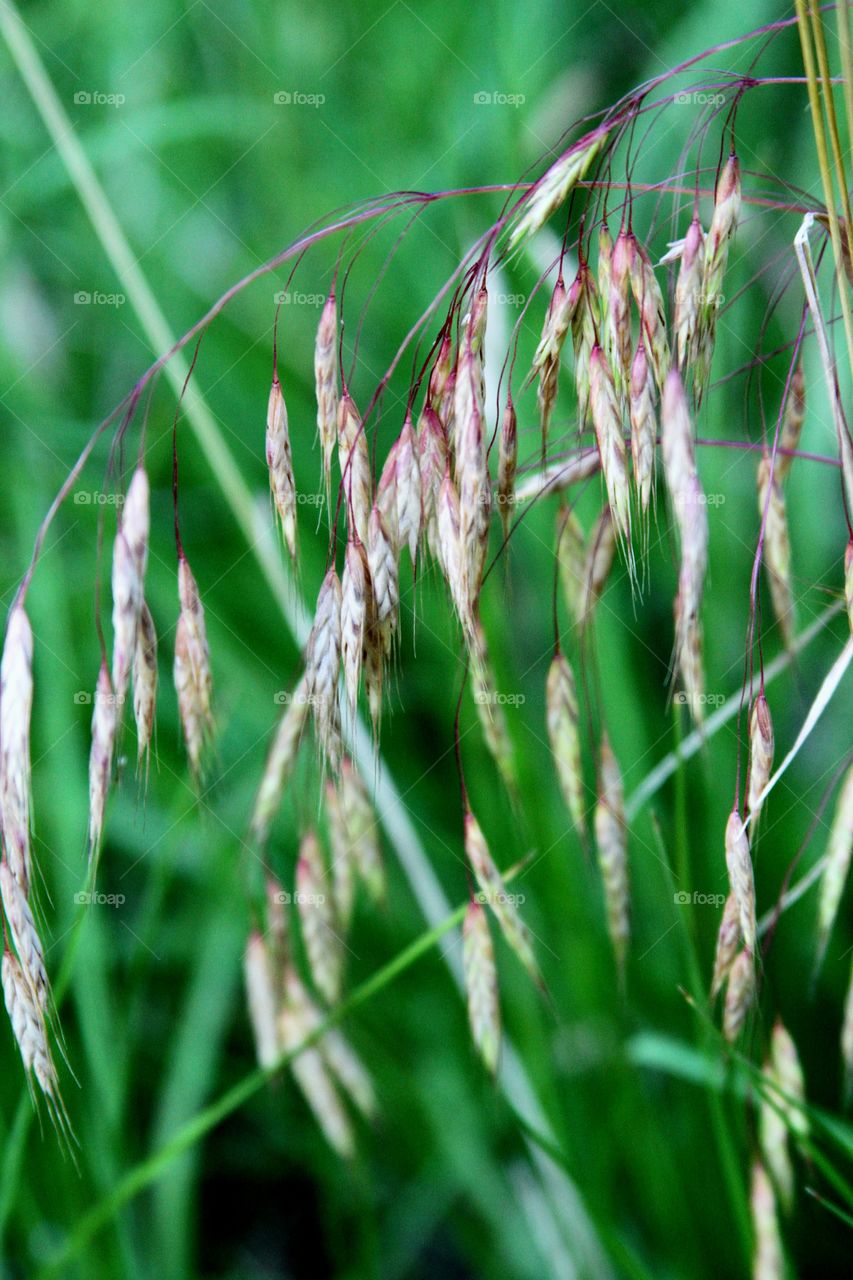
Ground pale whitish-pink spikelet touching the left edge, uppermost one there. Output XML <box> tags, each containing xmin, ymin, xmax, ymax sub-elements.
<box><xmin>0</xmin><ymin>604</ymin><xmax>32</xmax><ymax>892</ymax></box>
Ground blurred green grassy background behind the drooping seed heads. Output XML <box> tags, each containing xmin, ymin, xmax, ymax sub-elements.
<box><xmin>0</xmin><ymin>0</ymin><xmax>853</xmax><ymax>1280</ymax></box>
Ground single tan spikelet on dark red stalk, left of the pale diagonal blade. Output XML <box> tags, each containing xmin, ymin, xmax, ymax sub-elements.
<box><xmin>174</xmin><ymin>553</ymin><xmax>213</xmax><ymax>776</ymax></box>
